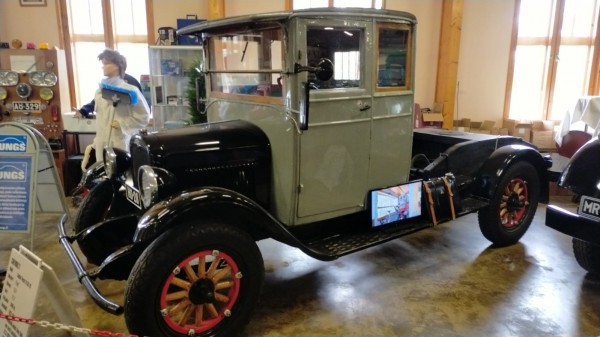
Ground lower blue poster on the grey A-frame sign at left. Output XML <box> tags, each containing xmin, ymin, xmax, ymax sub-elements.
<box><xmin>0</xmin><ymin>157</ymin><xmax>32</xmax><ymax>232</ymax></box>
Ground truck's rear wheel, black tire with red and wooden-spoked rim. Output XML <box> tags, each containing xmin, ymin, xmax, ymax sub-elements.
<box><xmin>478</xmin><ymin>161</ymin><xmax>540</xmax><ymax>247</ymax></box>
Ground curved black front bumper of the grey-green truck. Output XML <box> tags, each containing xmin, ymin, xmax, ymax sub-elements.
<box><xmin>58</xmin><ymin>214</ymin><xmax>123</xmax><ymax>315</ymax></box>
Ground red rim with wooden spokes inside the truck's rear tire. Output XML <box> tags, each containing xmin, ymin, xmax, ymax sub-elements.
<box><xmin>500</xmin><ymin>178</ymin><xmax>529</xmax><ymax>229</ymax></box>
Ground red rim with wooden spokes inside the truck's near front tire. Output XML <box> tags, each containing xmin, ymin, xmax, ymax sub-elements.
<box><xmin>160</xmin><ymin>250</ymin><xmax>242</xmax><ymax>335</ymax></box>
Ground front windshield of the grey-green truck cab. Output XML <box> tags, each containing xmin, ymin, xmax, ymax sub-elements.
<box><xmin>209</xmin><ymin>28</ymin><xmax>283</xmax><ymax>97</ymax></box>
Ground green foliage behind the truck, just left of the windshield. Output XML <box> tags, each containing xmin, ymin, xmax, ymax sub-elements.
<box><xmin>186</xmin><ymin>59</ymin><xmax>207</xmax><ymax>124</ymax></box>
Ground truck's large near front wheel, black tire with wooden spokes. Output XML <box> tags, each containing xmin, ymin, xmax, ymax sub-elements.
<box><xmin>125</xmin><ymin>223</ymin><xmax>265</xmax><ymax>337</ymax></box>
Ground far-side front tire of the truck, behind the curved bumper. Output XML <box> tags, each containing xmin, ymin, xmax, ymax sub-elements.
<box><xmin>73</xmin><ymin>180</ymin><xmax>135</xmax><ymax>265</ymax></box>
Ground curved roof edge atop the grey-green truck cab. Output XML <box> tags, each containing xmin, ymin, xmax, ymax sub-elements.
<box><xmin>177</xmin><ymin>8</ymin><xmax>417</xmax><ymax>35</ymax></box>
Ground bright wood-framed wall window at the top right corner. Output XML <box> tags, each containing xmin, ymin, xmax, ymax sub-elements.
<box><xmin>505</xmin><ymin>0</ymin><xmax>600</xmax><ymax>120</ymax></box>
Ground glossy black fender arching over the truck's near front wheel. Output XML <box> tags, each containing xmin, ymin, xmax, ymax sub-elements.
<box><xmin>133</xmin><ymin>187</ymin><xmax>300</xmax><ymax>246</ymax></box>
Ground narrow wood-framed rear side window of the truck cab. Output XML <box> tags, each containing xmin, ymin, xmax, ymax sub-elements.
<box><xmin>376</xmin><ymin>24</ymin><xmax>412</xmax><ymax>90</ymax></box>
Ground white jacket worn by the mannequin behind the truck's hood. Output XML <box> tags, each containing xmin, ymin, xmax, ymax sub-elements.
<box><xmin>94</xmin><ymin>78</ymin><xmax>150</xmax><ymax>161</ymax></box>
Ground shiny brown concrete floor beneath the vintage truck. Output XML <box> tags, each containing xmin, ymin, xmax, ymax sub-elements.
<box><xmin>0</xmin><ymin>197</ymin><xmax>600</xmax><ymax>337</ymax></box>
